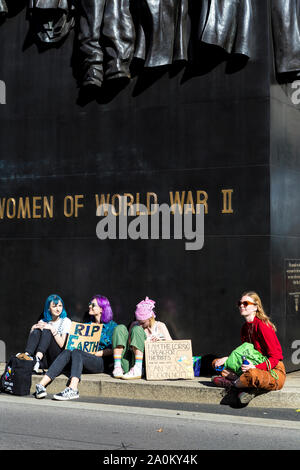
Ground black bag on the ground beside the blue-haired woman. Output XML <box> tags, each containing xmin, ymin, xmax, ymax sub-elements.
<box><xmin>0</xmin><ymin>356</ymin><xmax>35</xmax><ymax>396</ymax></box>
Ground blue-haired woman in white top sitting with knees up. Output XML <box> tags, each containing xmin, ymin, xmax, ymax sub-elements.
<box><xmin>17</xmin><ymin>294</ymin><xmax>71</xmax><ymax>373</ymax></box>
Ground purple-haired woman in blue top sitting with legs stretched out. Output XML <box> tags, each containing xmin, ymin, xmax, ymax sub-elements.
<box><xmin>35</xmin><ymin>295</ymin><xmax>117</xmax><ymax>400</ymax></box>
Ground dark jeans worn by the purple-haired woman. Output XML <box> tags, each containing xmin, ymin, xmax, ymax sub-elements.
<box><xmin>47</xmin><ymin>349</ymin><xmax>104</xmax><ymax>380</ymax></box>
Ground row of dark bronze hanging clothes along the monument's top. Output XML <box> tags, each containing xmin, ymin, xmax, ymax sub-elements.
<box><xmin>4</xmin><ymin>0</ymin><xmax>300</xmax><ymax>87</ymax></box>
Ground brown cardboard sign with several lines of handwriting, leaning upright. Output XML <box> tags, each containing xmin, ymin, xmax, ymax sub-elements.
<box><xmin>145</xmin><ymin>339</ymin><xmax>194</xmax><ymax>380</ymax></box>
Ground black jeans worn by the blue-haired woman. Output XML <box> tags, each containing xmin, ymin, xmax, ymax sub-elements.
<box><xmin>25</xmin><ymin>329</ymin><xmax>63</xmax><ymax>368</ymax></box>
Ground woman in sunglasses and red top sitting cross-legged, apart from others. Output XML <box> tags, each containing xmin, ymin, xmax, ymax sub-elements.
<box><xmin>212</xmin><ymin>292</ymin><xmax>286</xmax><ymax>404</ymax></box>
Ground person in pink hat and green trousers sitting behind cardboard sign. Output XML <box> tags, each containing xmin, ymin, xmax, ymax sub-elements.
<box><xmin>112</xmin><ymin>297</ymin><xmax>172</xmax><ymax>380</ymax></box>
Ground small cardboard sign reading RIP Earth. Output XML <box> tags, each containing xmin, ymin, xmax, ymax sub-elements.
<box><xmin>65</xmin><ymin>321</ymin><xmax>103</xmax><ymax>354</ymax></box>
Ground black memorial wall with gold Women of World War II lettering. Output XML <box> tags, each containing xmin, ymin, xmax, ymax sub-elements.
<box><xmin>0</xmin><ymin>0</ymin><xmax>300</xmax><ymax>371</ymax></box>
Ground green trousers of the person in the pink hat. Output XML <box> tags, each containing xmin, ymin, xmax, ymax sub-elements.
<box><xmin>112</xmin><ymin>325</ymin><xmax>147</xmax><ymax>373</ymax></box>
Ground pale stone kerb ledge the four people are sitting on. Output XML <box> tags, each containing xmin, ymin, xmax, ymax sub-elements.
<box><xmin>0</xmin><ymin>364</ymin><xmax>300</xmax><ymax>409</ymax></box>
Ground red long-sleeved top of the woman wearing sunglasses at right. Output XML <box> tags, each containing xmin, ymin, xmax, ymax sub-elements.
<box><xmin>241</xmin><ymin>317</ymin><xmax>283</xmax><ymax>370</ymax></box>
